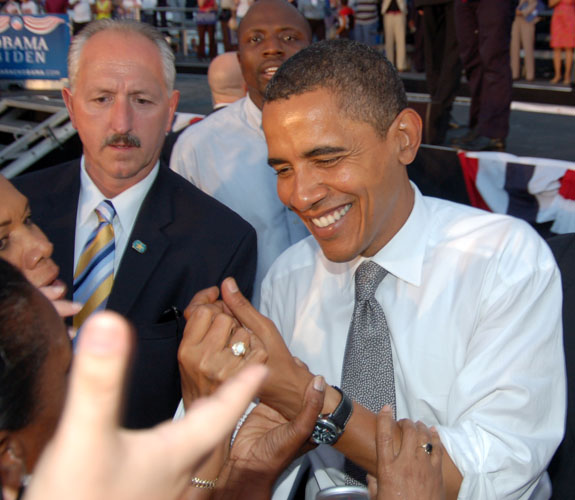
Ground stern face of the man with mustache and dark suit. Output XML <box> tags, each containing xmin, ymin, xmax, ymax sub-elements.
<box><xmin>63</xmin><ymin>30</ymin><xmax>179</xmax><ymax>197</ymax></box>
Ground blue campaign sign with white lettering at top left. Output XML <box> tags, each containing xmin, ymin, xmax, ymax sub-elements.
<box><xmin>0</xmin><ymin>14</ymin><xmax>70</xmax><ymax>80</ymax></box>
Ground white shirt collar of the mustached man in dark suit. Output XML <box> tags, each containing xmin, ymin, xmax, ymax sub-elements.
<box><xmin>78</xmin><ymin>156</ymin><xmax>160</xmax><ymax>237</ymax></box>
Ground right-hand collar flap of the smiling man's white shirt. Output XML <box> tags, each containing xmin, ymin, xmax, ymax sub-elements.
<box><xmin>362</xmin><ymin>183</ymin><xmax>431</xmax><ymax>286</ymax></box>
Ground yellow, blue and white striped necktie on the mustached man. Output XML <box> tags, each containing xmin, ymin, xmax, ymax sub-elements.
<box><xmin>74</xmin><ymin>200</ymin><xmax>116</xmax><ymax>328</ymax></box>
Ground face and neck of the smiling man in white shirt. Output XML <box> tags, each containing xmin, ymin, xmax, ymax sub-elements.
<box><xmin>263</xmin><ymin>89</ymin><xmax>413</xmax><ymax>262</ymax></box>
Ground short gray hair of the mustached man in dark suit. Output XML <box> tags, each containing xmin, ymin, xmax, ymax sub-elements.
<box><xmin>68</xmin><ymin>19</ymin><xmax>176</xmax><ymax>92</ymax></box>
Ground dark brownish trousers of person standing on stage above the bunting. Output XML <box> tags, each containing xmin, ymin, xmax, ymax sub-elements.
<box><xmin>455</xmin><ymin>0</ymin><xmax>517</xmax><ymax>139</ymax></box>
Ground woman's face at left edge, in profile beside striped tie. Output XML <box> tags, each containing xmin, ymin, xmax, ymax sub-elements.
<box><xmin>0</xmin><ymin>175</ymin><xmax>59</xmax><ymax>287</ymax></box>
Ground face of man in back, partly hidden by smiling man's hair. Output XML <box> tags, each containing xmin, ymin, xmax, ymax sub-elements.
<box><xmin>238</xmin><ymin>0</ymin><xmax>311</xmax><ymax>109</ymax></box>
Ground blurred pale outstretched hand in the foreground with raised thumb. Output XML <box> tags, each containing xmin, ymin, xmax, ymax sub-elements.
<box><xmin>25</xmin><ymin>312</ymin><xmax>267</xmax><ymax>500</ymax></box>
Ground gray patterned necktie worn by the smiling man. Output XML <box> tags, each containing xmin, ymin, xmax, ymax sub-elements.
<box><xmin>341</xmin><ymin>261</ymin><xmax>395</xmax><ymax>484</ymax></box>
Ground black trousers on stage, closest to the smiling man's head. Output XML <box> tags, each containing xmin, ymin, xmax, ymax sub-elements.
<box><xmin>423</xmin><ymin>0</ymin><xmax>462</xmax><ymax>144</ymax></box>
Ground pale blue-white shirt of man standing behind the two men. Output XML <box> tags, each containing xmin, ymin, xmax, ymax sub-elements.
<box><xmin>170</xmin><ymin>97</ymin><xmax>309</xmax><ymax>307</ymax></box>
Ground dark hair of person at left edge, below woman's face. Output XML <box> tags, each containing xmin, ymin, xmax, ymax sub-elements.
<box><xmin>0</xmin><ymin>259</ymin><xmax>49</xmax><ymax>431</ymax></box>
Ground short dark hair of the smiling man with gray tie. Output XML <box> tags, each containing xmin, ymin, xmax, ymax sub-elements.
<box><xmin>265</xmin><ymin>39</ymin><xmax>407</xmax><ymax>137</ymax></box>
